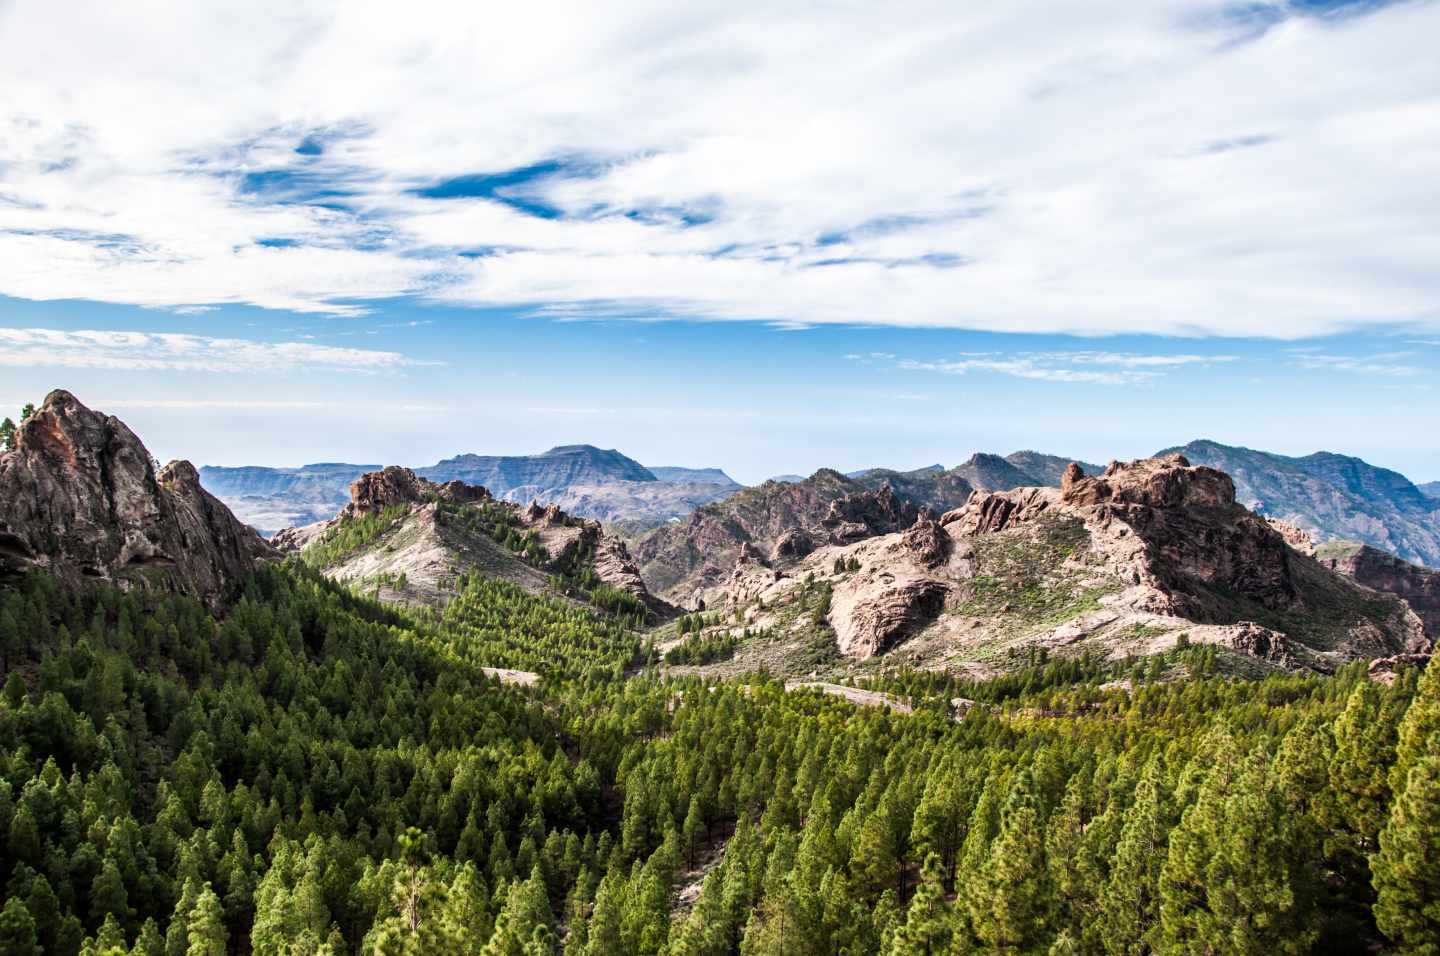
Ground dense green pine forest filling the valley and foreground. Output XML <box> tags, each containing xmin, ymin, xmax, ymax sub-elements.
<box><xmin>0</xmin><ymin>562</ymin><xmax>1440</xmax><ymax>956</ymax></box>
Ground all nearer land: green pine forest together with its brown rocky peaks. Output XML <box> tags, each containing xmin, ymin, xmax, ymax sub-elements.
<box><xmin>0</xmin><ymin>392</ymin><xmax>1440</xmax><ymax>956</ymax></box>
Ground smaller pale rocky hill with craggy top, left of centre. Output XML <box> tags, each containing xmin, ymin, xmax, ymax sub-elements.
<box><xmin>274</xmin><ymin>465</ymin><xmax>670</xmax><ymax>621</ymax></box>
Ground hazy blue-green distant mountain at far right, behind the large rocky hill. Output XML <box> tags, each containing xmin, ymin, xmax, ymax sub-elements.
<box><xmin>1158</xmin><ymin>441</ymin><xmax>1440</xmax><ymax>567</ymax></box>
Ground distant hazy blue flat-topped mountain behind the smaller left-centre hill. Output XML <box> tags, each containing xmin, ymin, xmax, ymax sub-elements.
<box><xmin>200</xmin><ymin>445</ymin><xmax>742</xmax><ymax>534</ymax></box>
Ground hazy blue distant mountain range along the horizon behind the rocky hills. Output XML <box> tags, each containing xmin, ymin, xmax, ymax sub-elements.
<box><xmin>200</xmin><ymin>441</ymin><xmax>1440</xmax><ymax>575</ymax></box>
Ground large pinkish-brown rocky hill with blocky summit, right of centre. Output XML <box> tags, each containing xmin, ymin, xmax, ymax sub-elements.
<box><xmin>665</xmin><ymin>455</ymin><xmax>1430</xmax><ymax>677</ymax></box>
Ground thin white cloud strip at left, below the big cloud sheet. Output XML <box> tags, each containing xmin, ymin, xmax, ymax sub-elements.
<box><xmin>0</xmin><ymin>328</ymin><xmax>422</xmax><ymax>374</ymax></box>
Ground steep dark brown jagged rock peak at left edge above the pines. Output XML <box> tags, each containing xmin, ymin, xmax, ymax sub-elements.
<box><xmin>0</xmin><ymin>390</ymin><xmax>276</xmax><ymax>608</ymax></box>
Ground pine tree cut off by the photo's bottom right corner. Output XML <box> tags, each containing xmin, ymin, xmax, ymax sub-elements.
<box><xmin>1371</xmin><ymin>736</ymin><xmax>1440</xmax><ymax>956</ymax></box>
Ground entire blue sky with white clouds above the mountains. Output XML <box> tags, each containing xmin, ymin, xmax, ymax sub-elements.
<box><xmin>0</xmin><ymin>0</ymin><xmax>1440</xmax><ymax>481</ymax></box>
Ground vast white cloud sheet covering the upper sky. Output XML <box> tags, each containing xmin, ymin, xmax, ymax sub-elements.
<box><xmin>0</xmin><ymin>0</ymin><xmax>1440</xmax><ymax>335</ymax></box>
